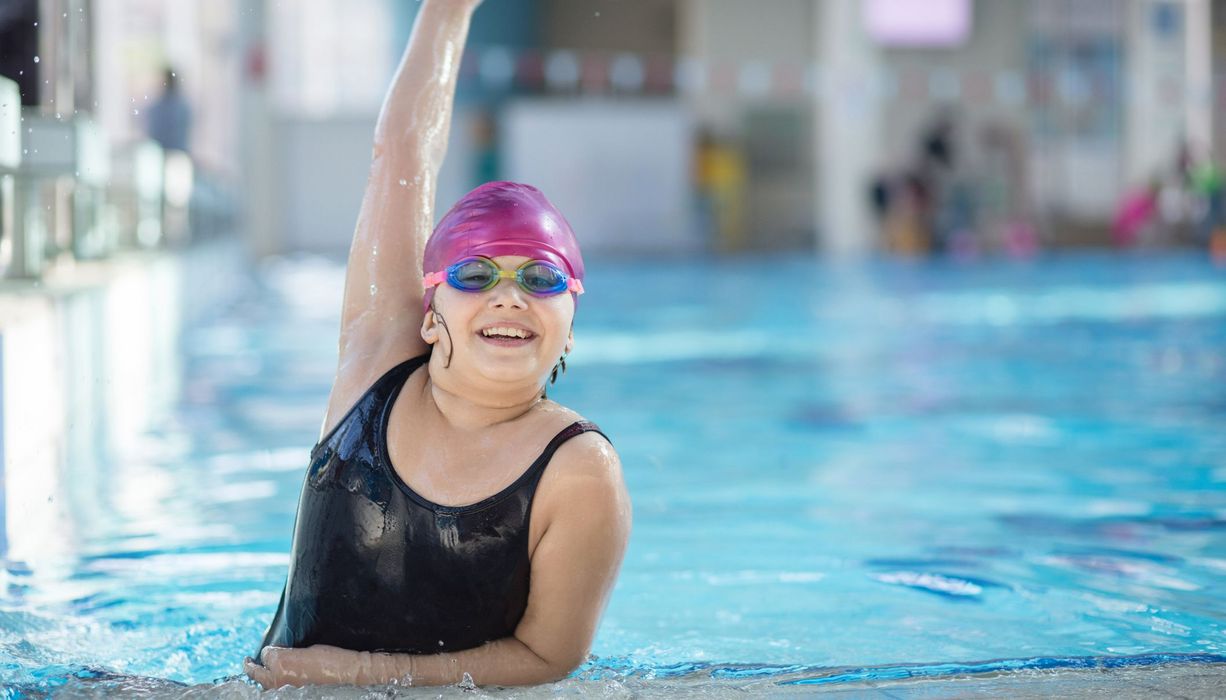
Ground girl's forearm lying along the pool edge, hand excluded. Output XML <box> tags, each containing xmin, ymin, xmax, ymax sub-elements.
<box><xmin>357</xmin><ymin>636</ymin><xmax>577</xmax><ymax>685</ymax></box>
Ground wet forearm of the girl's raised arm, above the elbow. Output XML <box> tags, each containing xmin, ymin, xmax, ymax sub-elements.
<box><xmin>375</xmin><ymin>0</ymin><xmax>481</xmax><ymax>174</ymax></box>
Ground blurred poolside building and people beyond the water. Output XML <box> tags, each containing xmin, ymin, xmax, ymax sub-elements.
<box><xmin>0</xmin><ymin>0</ymin><xmax>1226</xmax><ymax>266</ymax></box>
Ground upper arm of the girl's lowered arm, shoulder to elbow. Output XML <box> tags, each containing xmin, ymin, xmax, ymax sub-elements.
<box><xmin>515</xmin><ymin>433</ymin><xmax>630</xmax><ymax>672</ymax></box>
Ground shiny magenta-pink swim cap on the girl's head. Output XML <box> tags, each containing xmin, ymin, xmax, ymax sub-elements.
<box><xmin>422</xmin><ymin>181</ymin><xmax>584</xmax><ymax>309</ymax></box>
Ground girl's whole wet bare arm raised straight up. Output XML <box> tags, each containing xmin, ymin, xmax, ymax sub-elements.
<box><xmin>329</xmin><ymin>0</ymin><xmax>481</xmax><ymax>421</ymax></box>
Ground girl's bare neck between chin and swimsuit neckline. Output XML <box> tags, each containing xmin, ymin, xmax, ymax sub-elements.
<box><xmin>425</xmin><ymin>358</ymin><xmax>541</xmax><ymax>430</ymax></box>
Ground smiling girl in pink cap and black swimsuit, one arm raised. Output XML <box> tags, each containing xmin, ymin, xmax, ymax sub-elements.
<box><xmin>244</xmin><ymin>0</ymin><xmax>630</xmax><ymax>688</ymax></box>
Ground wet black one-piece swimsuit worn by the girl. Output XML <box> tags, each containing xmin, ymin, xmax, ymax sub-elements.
<box><xmin>256</xmin><ymin>354</ymin><xmax>603</xmax><ymax>658</ymax></box>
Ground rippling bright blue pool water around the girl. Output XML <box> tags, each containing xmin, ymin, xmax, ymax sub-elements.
<box><xmin>0</xmin><ymin>255</ymin><xmax>1226</xmax><ymax>693</ymax></box>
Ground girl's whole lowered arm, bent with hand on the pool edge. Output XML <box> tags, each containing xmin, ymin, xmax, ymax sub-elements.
<box><xmin>245</xmin><ymin>434</ymin><xmax>630</xmax><ymax>688</ymax></box>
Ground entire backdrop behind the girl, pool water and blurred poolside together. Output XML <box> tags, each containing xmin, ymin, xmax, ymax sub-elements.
<box><xmin>0</xmin><ymin>0</ymin><xmax>1226</xmax><ymax>684</ymax></box>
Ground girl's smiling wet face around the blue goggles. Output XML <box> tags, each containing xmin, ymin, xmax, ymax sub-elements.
<box><xmin>422</xmin><ymin>255</ymin><xmax>575</xmax><ymax>386</ymax></box>
